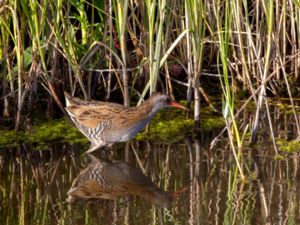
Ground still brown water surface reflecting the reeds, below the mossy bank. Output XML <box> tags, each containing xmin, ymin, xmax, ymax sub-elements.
<box><xmin>0</xmin><ymin>110</ymin><xmax>300</xmax><ymax>225</ymax></box>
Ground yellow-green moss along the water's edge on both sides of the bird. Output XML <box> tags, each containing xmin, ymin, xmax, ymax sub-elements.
<box><xmin>0</xmin><ymin>108</ymin><xmax>224</xmax><ymax>150</ymax></box>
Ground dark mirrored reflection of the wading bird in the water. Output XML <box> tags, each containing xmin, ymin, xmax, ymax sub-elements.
<box><xmin>68</xmin><ymin>154</ymin><xmax>172</xmax><ymax>207</ymax></box>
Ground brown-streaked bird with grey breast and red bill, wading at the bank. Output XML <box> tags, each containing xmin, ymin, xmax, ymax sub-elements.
<box><xmin>65</xmin><ymin>92</ymin><xmax>188</xmax><ymax>153</ymax></box>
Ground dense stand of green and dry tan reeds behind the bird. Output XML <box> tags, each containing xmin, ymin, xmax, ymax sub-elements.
<box><xmin>0</xmin><ymin>0</ymin><xmax>300</xmax><ymax>177</ymax></box>
